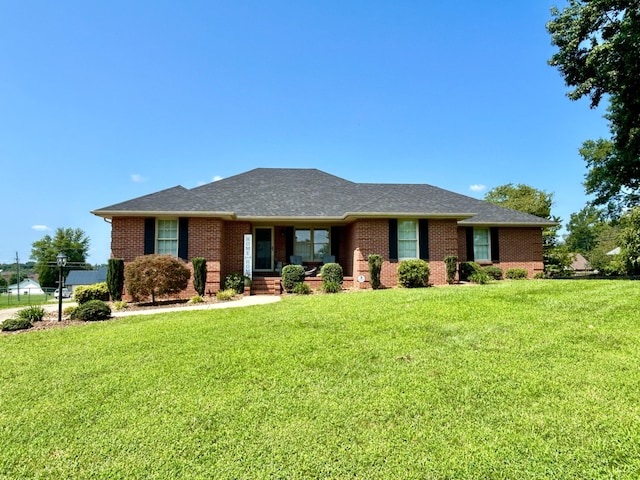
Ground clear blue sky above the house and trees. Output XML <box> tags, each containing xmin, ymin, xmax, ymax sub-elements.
<box><xmin>0</xmin><ymin>0</ymin><xmax>608</xmax><ymax>264</ymax></box>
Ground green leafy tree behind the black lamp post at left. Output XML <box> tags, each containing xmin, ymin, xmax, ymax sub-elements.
<box><xmin>31</xmin><ymin>228</ymin><xmax>90</xmax><ymax>287</ymax></box>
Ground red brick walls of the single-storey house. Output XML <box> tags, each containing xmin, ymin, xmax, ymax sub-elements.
<box><xmin>111</xmin><ymin>217</ymin><xmax>543</xmax><ymax>296</ymax></box>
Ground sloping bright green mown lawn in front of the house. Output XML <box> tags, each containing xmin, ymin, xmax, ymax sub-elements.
<box><xmin>0</xmin><ymin>281</ymin><xmax>640</xmax><ymax>479</ymax></box>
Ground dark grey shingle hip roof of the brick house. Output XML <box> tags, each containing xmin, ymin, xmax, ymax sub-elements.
<box><xmin>92</xmin><ymin>168</ymin><xmax>554</xmax><ymax>226</ymax></box>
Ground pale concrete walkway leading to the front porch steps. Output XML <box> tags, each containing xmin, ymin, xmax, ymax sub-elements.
<box><xmin>0</xmin><ymin>295</ymin><xmax>280</xmax><ymax>324</ymax></box>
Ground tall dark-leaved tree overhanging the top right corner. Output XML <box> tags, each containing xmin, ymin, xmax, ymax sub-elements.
<box><xmin>547</xmin><ymin>0</ymin><xmax>640</xmax><ymax>213</ymax></box>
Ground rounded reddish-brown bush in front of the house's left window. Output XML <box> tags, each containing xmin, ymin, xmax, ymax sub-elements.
<box><xmin>124</xmin><ymin>254</ymin><xmax>191</xmax><ymax>303</ymax></box>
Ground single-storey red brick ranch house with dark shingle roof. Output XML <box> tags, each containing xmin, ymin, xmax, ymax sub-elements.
<box><xmin>91</xmin><ymin>168</ymin><xmax>554</xmax><ymax>295</ymax></box>
